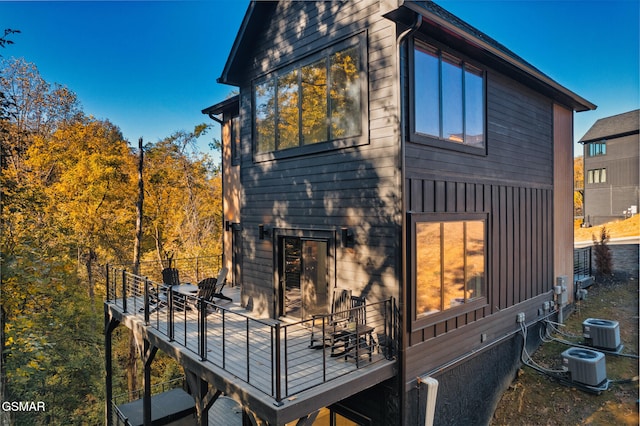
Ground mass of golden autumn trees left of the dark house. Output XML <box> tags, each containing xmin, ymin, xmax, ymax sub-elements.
<box><xmin>0</xmin><ymin>59</ymin><xmax>221</xmax><ymax>424</ymax></box>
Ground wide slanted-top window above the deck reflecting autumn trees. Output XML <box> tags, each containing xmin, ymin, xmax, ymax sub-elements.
<box><xmin>253</xmin><ymin>37</ymin><xmax>366</xmax><ymax>160</ymax></box>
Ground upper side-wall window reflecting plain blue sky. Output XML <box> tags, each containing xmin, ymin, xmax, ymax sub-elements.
<box><xmin>412</xmin><ymin>41</ymin><xmax>485</xmax><ymax>148</ymax></box>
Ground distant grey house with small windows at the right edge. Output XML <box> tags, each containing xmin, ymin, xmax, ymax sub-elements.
<box><xmin>579</xmin><ymin>110</ymin><xmax>640</xmax><ymax>226</ymax></box>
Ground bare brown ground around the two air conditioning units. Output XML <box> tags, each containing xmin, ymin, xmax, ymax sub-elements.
<box><xmin>491</xmin><ymin>279</ymin><xmax>639</xmax><ymax>426</ymax></box>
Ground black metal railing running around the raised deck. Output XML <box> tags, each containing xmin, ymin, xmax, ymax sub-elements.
<box><xmin>107</xmin><ymin>266</ymin><xmax>398</xmax><ymax>403</ymax></box>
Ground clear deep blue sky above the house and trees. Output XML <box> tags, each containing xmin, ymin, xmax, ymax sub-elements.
<box><xmin>0</xmin><ymin>0</ymin><xmax>640</xmax><ymax>153</ymax></box>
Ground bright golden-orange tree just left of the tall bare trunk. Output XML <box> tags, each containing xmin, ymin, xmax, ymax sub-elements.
<box><xmin>26</xmin><ymin>119</ymin><xmax>135</xmax><ymax>301</ymax></box>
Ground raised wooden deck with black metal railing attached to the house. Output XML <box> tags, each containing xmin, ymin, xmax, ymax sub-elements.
<box><xmin>105</xmin><ymin>264</ymin><xmax>397</xmax><ymax>424</ymax></box>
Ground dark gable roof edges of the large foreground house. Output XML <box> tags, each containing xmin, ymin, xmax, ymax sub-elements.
<box><xmin>218</xmin><ymin>0</ymin><xmax>597</xmax><ymax>111</ymax></box>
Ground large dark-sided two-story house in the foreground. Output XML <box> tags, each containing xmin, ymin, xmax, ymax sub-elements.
<box><xmin>105</xmin><ymin>0</ymin><xmax>595</xmax><ymax>425</ymax></box>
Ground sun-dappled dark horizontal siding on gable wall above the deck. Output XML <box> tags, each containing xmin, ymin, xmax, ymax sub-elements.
<box><xmin>235</xmin><ymin>0</ymin><xmax>402</xmax><ymax>317</ymax></box>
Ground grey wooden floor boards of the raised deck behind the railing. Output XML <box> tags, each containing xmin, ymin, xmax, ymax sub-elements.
<box><xmin>109</xmin><ymin>288</ymin><xmax>384</xmax><ymax>396</ymax></box>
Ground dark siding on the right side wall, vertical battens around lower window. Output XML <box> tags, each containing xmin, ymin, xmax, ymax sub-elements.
<box><xmin>405</xmin><ymin>65</ymin><xmax>554</xmax><ymax>374</ymax></box>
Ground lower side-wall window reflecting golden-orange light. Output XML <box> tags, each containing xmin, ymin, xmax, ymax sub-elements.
<box><xmin>413</xmin><ymin>214</ymin><xmax>486</xmax><ymax>320</ymax></box>
